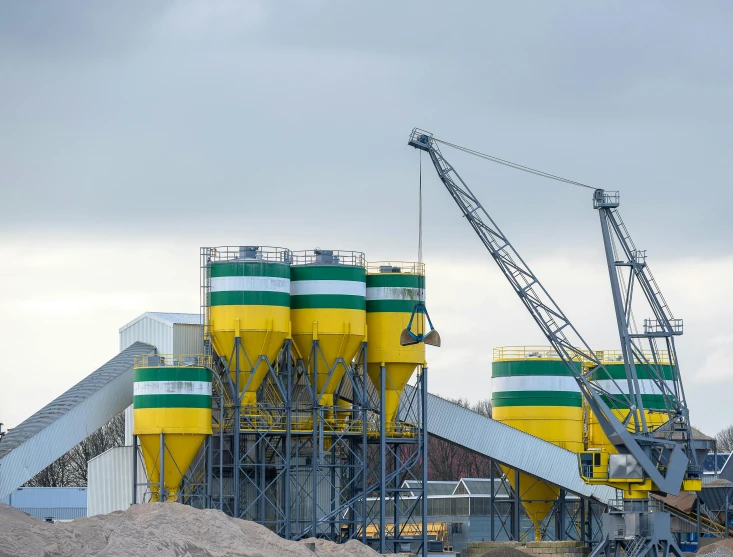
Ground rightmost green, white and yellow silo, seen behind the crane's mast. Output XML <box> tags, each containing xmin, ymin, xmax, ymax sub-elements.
<box><xmin>588</xmin><ymin>350</ymin><xmax>675</xmax><ymax>453</ymax></box>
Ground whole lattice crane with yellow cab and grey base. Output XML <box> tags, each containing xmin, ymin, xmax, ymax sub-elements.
<box><xmin>408</xmin><ymin>128</ymin><xmax>702</xmax><ymax>557</ymax></box>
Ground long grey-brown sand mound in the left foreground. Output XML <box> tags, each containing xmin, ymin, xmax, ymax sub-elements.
<box><xmin>0</xmin><ymin>503</ymin><xmax>379</xmax><ymax>557</ymax></box>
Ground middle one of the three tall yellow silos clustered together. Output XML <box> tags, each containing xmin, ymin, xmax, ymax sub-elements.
<box><xmin>290</xmin><ymin>249</ymin><xmax>366</xmax><ymax>407</ymax></box>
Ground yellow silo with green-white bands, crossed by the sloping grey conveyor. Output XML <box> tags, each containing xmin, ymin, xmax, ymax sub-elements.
<box><xmin>491</xmin><ymin>347</ymin><xmax>583</xmax><ymax>540</ymax></box>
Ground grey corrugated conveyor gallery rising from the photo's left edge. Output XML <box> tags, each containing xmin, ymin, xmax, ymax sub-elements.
<box><xmin>0</xmin><ymin>342</ymin><xmax>155</xmax><ymax>499</ymax></box>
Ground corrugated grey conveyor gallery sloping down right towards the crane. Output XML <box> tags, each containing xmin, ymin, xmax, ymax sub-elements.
<box><xmin>405</xmin><ymin>385</ymin><xmax>615</xmax><ymax>503</ymax></box>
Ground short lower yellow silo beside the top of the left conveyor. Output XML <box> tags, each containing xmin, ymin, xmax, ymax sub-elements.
<box><xmin>133</xmin><ymin>356</ymin><xmax>211</xmax><ymax>501</ymax></box>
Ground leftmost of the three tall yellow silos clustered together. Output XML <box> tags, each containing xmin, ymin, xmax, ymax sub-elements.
<box><xmin>208</xmin><ymin>246</ymin><xmax>290</xmax><ymax>406</ymax></box>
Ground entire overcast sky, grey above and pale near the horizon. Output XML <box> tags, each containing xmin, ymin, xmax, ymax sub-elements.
<box><xmin>0</xmin><ymin>0</ymin><xmax>733</xmax><ymax>433</ymax></box>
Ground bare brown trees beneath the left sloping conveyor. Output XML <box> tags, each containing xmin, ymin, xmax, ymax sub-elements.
<box><xmin>25</xmin><ymin>412</ymin><xmax>125</xmax><ymax>487</ymax></box>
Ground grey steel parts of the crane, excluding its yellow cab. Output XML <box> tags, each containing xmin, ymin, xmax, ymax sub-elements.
<box><xmin>408</xmin><ymin>128</ymin><xmax>699</xmax><ymax>557</ymax></box>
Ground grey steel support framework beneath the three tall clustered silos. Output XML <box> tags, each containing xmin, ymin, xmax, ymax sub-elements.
<box><xmin>197</xmin><ymin>246</ymin><xmax>427</xmax><ymax>553</ymax></box>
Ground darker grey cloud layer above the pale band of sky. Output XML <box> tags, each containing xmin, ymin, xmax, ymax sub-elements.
<box><xmin>0</xmin><ymin>1</ymin><xmax>733</xmax><ymax>255</ymax></box>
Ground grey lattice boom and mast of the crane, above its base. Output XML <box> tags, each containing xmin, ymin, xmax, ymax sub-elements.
<box><xmin>408</xmin><ymin>128</ymin><xmax>696</xmax><ymax>494</ymax></box>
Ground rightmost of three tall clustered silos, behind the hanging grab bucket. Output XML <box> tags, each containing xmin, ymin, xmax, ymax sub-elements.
<box><xmin>366</xmin><ymin>262</ymin><xmax>425</xmax><ymax>431</ymax></box>
